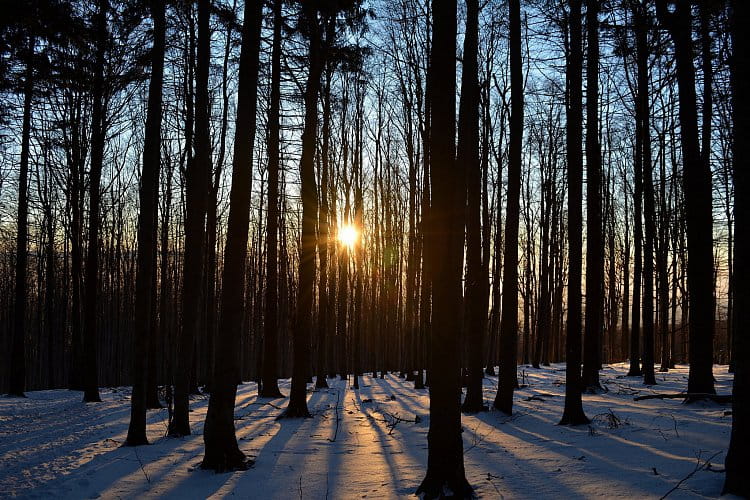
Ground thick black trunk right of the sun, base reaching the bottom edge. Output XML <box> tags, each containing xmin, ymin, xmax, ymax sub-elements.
<box><xmin>416</xmin><ymin>0</ymin><xmax>472</xmax><ymax>498</ymax></box>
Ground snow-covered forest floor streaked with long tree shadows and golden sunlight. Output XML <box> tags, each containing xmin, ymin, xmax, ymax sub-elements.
<box><xmin>0</xmin><ymin>364</ymin><xmax>731</xmax><ymax>499</ymax></box>
